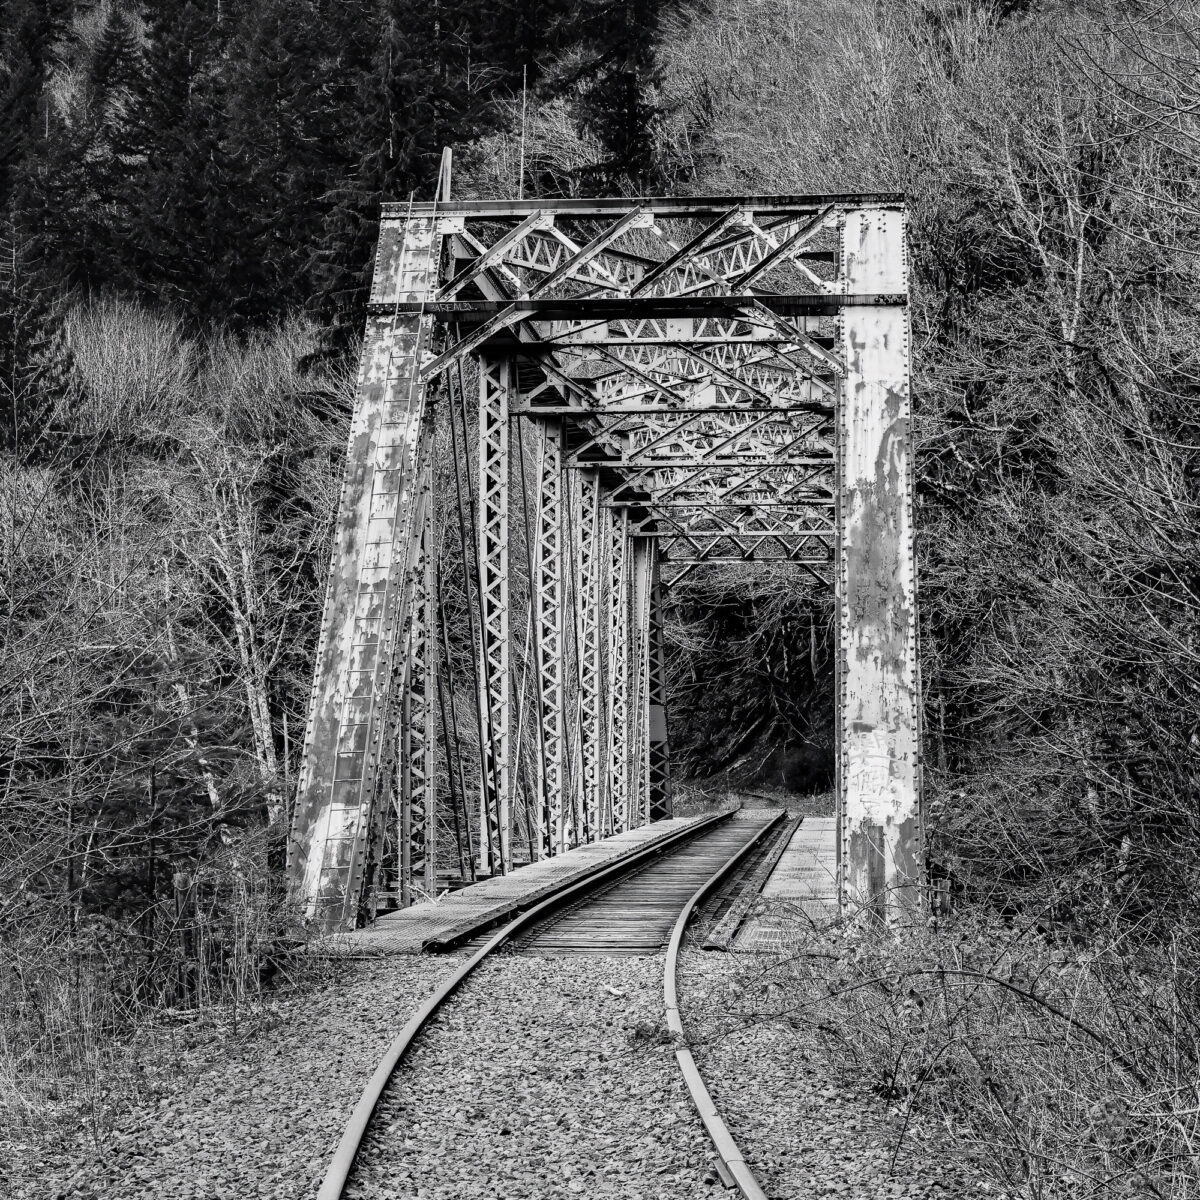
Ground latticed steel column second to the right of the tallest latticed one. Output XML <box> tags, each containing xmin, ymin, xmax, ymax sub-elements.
<box><xmin>575</xmin><ymin>470</ymin><xmax>604</xmax><ymax>841</ymax></box>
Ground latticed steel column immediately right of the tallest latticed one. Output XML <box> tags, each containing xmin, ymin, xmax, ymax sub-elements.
<box><xmin>529</xmin><ymin>418</ymin><xmax>568</xmax><ymax>857</ymax></box>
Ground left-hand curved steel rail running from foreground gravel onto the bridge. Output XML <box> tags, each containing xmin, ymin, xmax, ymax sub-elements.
<box><xmin>317</xmin><ymin>809</ymin><xmax>734</xmax><ymax>1200</ymax></box>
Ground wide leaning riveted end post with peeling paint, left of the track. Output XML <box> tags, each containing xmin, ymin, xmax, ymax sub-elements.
<box><xmin>288</xmin><ymin>220</ymin><xmax>439</xmax><ymax>929</ymax></box>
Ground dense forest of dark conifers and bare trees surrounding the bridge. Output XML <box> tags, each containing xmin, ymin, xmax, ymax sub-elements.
<box><xmin>0</xmin><ymin>0</ymin><xmax>1200</xmax><ymax>1196</ymax></box>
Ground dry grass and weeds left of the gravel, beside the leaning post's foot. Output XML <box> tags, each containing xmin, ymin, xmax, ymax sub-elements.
<box><xmin>0</xmin><ymin>836</ymin><xmax>326</xmax><ymax>1130</ymax></box>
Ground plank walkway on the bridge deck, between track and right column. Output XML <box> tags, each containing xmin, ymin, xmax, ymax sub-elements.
<box><xmin>733</xmin><ymin>817</ymin><xmax>838</xmax><ymax>953</ymax></box>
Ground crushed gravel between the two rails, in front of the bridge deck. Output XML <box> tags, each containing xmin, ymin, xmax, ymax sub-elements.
<box><xmin>347</xmin><ymin>955</ymin><xmax>726</xmax><ymax>1200</ymax></box>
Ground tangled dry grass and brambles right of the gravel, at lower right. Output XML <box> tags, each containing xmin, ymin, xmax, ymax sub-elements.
<box><xmin>720</xmin><ymin>914</ymin><xmax>1200</xmax><ymax>1200</ymax></box>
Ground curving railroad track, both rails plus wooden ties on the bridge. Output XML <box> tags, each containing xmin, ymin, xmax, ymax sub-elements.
<box><xmin>318</xmin><ymin>812</ymin><xmax>785</xmax><ymax>1200</ymax></box>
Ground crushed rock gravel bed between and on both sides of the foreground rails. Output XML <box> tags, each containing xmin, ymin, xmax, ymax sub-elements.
<box><xmin>11</xmin><ymin>907</ymin><xmax>995</xmax><ymax>1200</ymax></box>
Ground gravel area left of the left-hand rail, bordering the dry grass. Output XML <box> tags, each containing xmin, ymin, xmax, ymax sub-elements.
<box><xmin>9</xmin><ymin>955</ymin><xmax>455</xmax><ymax>1200</ymax></box>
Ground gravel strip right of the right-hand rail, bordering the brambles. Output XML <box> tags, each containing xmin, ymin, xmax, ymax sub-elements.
<box><xmin>678</xmin><ymin>950</ymin><xmax>995</xmax><ymax>1200</ymax></box>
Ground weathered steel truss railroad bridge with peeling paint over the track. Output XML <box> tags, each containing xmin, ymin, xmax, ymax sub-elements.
<box><xmin>289</xmin><ymin>188</ymin><xmax>922</xmax><ymax>930</ymax></box>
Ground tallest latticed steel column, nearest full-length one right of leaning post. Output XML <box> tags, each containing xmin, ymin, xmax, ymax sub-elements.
<box><xmin>479</xmin><ymin>358</ymin><xmax>512</xmax><ymax>872</ymax></box>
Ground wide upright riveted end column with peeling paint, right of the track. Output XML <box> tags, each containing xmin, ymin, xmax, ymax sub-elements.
<box><xmin>838</xmin><ymin>206</ymin><xmax>923</xmax><ymax>919</ymax></box>
